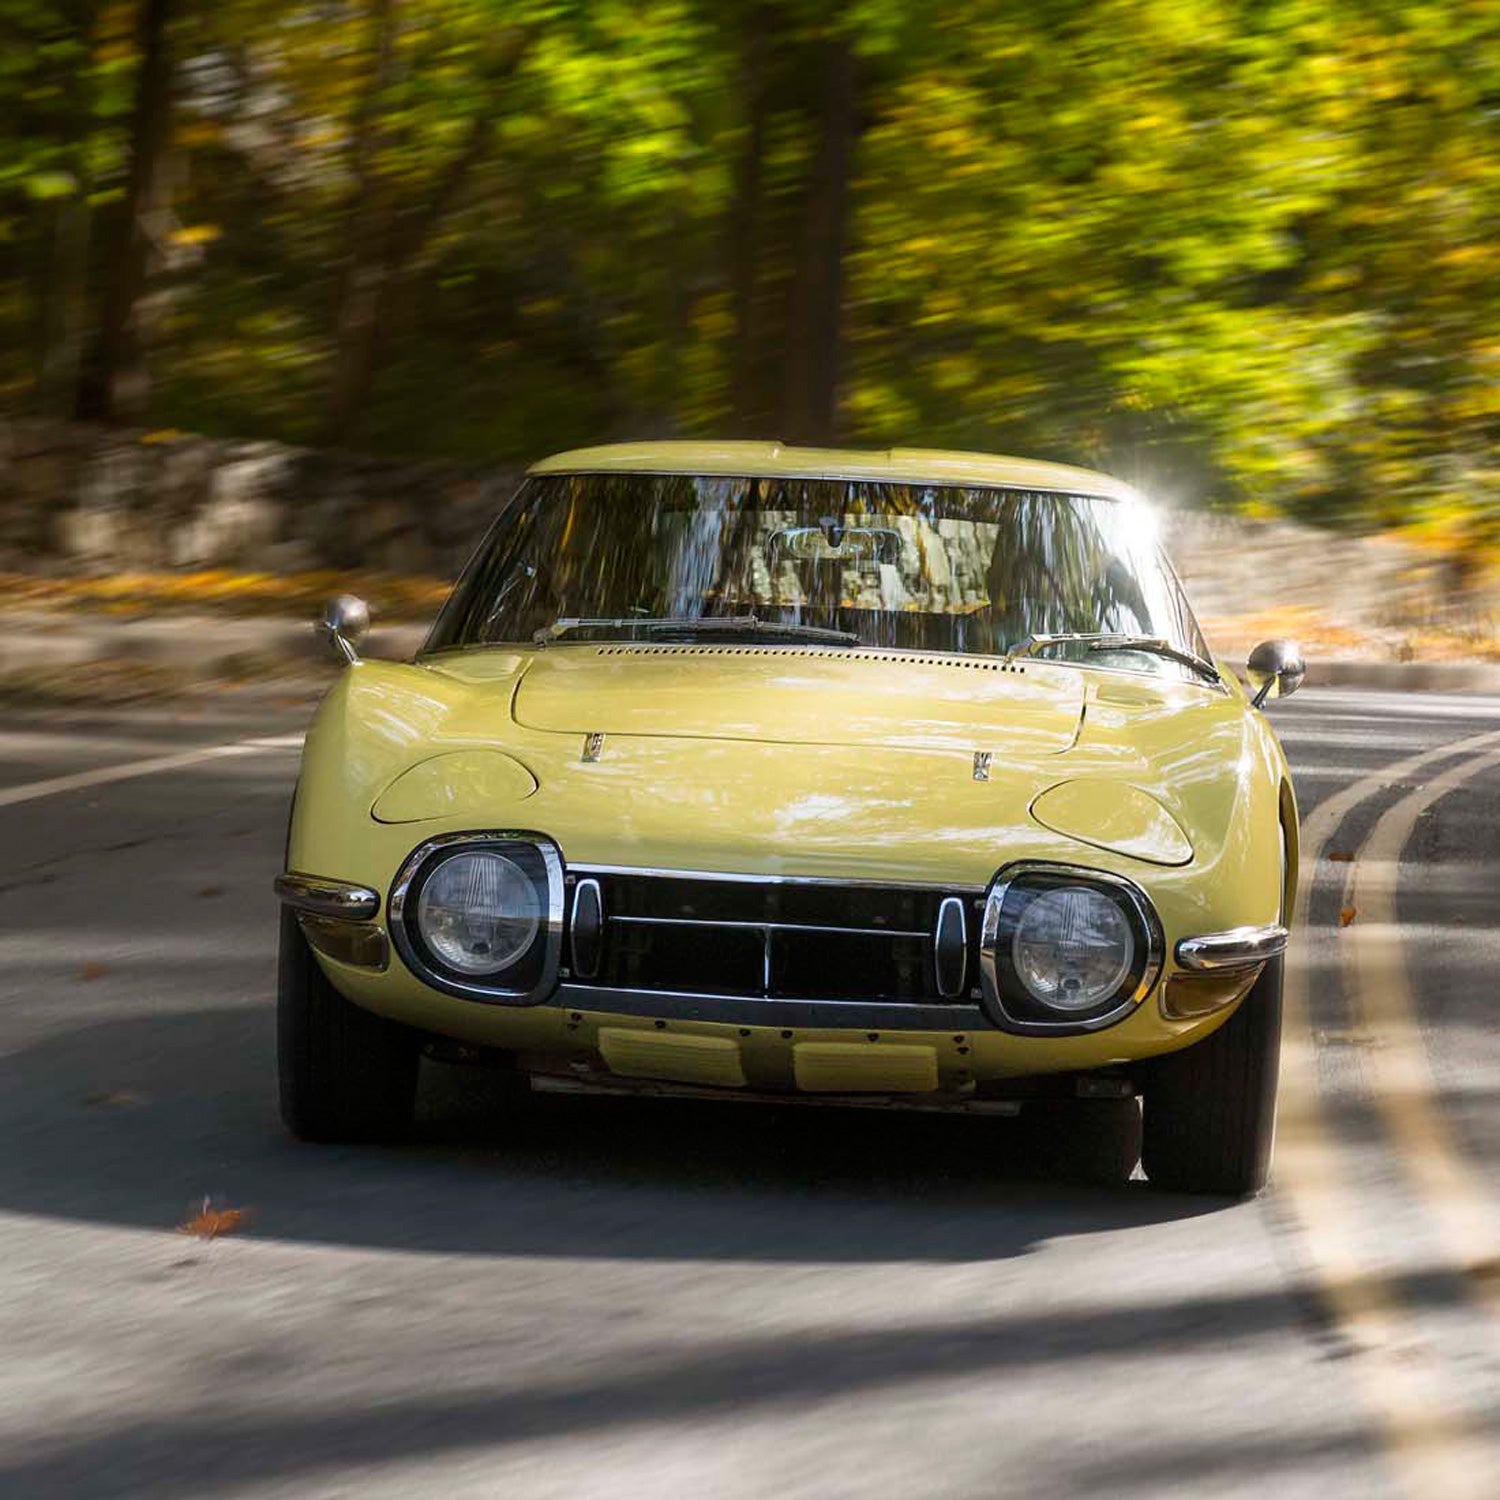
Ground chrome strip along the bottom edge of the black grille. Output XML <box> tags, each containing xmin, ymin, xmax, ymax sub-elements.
<box><xmin>555</xmin><ymin>983</ymin><xmax>990</xmax><ymax>1034</ymax></box>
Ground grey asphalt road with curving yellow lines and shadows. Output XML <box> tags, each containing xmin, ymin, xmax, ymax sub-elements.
<box><xmin>0</xmin><ymin>690</ymin><xmax>1500</xmax><ymax>1500</ymax></box>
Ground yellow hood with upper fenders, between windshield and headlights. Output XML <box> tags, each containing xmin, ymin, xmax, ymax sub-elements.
<box><xmin>294</xmin><ymin>648</ymin><xmax>1284</xmax><ymax>900</ymax></box>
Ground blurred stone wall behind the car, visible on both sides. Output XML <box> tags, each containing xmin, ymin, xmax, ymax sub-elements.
<box><xmin>0</xmin><ymin>422</ymin><xmax>1473</xmax><ymax>630</ymax></box>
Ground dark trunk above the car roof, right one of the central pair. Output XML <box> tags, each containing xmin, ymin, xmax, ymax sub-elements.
<box><xmin>782</xmin><ymin>36</ymin><xmax>860</xmax><ymax>444</ymax></box>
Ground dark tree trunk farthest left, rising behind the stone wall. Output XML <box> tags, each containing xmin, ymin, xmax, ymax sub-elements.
<box><xmin>77</xmin><ymin>0</ymin><xmax>173</xmax><ymax>422</ymax></box>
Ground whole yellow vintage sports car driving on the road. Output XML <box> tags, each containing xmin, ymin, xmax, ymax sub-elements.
<box><xmin>278</xmin><ymin>443</ymin><xmax>1302</xmax><ymax>1194</ymax></box>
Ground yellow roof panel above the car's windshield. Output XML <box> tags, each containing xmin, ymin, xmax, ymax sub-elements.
<box><xmin>527</xmin><ymin>443</ymin><xmax>1140</xmax><ymax>500</ymax></box>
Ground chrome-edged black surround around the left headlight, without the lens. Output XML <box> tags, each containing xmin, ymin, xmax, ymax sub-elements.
<box><xmin>386</xmin><ymin>830</ymin><xmax>563</xmax><ymax>1005</ymax></box>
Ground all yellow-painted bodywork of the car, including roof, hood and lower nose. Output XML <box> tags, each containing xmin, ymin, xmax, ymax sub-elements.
<box><xmin>288</xmin><ymin>444</ymin><xmax>1296</xmax><ymax>1092</ymax></box>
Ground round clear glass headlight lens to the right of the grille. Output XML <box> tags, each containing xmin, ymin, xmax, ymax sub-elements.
<box><xmin>1011</xmin><ymin>885</ymin><xmax>1136</xmax><ymax>1011</ymax></box>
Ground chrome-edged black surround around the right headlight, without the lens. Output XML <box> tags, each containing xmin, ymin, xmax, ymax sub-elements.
<box><xmin>980</xmin><ymin>860</ymin><xmax>1166</xmax><ymax>1037</ymax></box>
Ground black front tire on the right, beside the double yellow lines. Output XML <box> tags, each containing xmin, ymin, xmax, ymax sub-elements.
<box><xmin>1142</xmin><ymin>959</ymin><xmax>1281</xmax><ymax>1197</ymax></box>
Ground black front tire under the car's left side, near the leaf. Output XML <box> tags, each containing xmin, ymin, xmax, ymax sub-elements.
<box><xmin>276</xmin><ymin>908</ymin><xmax>422</xmax><ymax>1142</ymax></box>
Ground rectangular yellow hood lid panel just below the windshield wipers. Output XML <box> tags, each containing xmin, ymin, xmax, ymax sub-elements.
<box><xmin>498</xmin><ymin>645</ymin><xmax>1085</xmax><ymax>758</ymax></box>
